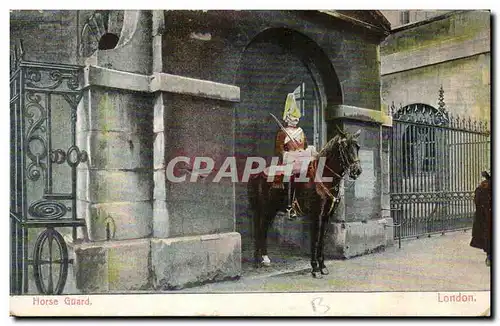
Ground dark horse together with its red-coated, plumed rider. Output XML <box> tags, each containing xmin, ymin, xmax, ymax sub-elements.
<box><xmin>248</xmin><ymin>104</ymin><xmax>362</xmax><ymax>278</ymax></box>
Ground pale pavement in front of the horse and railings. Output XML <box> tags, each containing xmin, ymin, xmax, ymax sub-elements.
<box><xmin>181</xmin><ymin>230</ymin><xmax>490</xmax><ymax>293</ymax></box>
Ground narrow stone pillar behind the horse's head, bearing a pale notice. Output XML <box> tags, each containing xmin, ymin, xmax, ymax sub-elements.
<box><xmin>325</xmin><ymin>105</ymin><xmax>393</xmax><ymax>258</ymax></box>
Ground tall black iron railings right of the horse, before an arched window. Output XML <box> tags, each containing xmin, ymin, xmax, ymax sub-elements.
<box><xmin>391</xmin><ymin>95</ymin><xmax>490</xmax><ymax>238</ymax></box>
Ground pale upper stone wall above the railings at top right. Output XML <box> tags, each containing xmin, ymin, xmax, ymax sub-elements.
<box><xmin>381</xmin><ymin>11</ymin><xmax>491</xmax><ymax>119</ymax></box>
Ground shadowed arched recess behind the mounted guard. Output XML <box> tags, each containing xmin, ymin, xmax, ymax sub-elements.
<box><xmin>235</xmin><ymin>28</ymin><xmax>342</xmax><ymax>261</ymax></box>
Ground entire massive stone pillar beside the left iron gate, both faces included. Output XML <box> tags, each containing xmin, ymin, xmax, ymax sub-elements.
<box><xmin>74</xmin><ymin>11</ymin><xmax>241</xmax><ymax>292</ymax></box>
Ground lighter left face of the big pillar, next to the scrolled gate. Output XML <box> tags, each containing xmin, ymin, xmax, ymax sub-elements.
<box><xmin>74</xmin><ymin>11</ymin><xmax>153</xmax><ymax>292</ymax></box>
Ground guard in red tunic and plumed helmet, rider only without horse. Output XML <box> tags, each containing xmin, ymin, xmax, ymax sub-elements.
<box><xmin>271</xmin><ymin>93</ymin><xmax>317</xmax><ymax>220</ymax></box>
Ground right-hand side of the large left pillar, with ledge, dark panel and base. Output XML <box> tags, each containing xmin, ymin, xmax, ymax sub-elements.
<box><xmin>151</xmin><ymin>73</ymin><xmax>241</xmax><ymax>290</ymax></box>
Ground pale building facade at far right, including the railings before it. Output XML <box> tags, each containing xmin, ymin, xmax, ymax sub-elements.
<box><xmin>381</xmin><ymin>11</ymin><xmax>491</xmax><ymax>237</ymax></box>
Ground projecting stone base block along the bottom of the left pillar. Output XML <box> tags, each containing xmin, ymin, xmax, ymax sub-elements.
<box><xmin>73</xmin><ymin>232</ymin><xmax>241</xmax><ymax>293</ymax></box>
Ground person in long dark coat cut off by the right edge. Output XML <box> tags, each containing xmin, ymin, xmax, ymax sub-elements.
<box><xmin>470</xmin><ymin>171</ymin><xmax>492</xmax><ymax>266</ymax></box>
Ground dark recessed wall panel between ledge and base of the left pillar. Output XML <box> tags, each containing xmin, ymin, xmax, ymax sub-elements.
<box><xmin>159</xmin><ymin>95</ymin><xmax>234</xmax><ymax>237</ymax></box>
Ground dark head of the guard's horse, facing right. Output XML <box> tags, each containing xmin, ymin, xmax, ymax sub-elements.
<box><xmin>320</xmin><ymin>129</ymin><xmax>363</xmax><ymax>180</ymax></box>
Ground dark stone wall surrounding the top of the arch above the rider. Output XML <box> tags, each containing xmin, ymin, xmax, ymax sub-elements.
<box><xmin>163</xmin><ymin>10</ymin><xmax>380</xmax><ymax>110</ymax></box>
